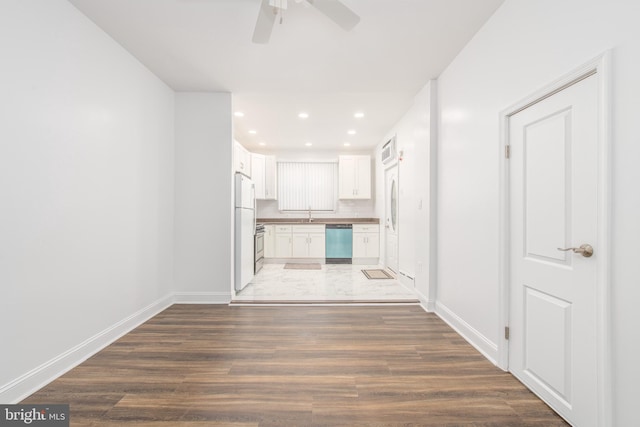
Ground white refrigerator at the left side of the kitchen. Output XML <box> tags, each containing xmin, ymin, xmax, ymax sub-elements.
<box><xmin>235</xmin><ymin>173</ymin><xmax>256</xmax><ymax>291</ymax></box>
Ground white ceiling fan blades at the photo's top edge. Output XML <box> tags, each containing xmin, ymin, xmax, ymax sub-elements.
<box><xmin>252</xmin><ymin>0</ymin><xmax>360</xmax><ymax>44</ymax></box>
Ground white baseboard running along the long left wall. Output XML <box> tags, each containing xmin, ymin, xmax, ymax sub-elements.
<box><xmin>0</xmin><ymin>295</ymin><xmax>173</xmax><ymax>403</ymax></box>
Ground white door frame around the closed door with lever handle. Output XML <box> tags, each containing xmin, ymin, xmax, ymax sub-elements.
<box><xmin>497</xmin><ymin>51</ymin><xmax>613</xmax><ymax>426</ymax></box>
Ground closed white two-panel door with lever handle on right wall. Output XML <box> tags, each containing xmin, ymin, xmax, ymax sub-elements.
<box><xmin>509</xmin><ymin>75</ymin><xmax>599</xmax><ymax>427</ymax></box>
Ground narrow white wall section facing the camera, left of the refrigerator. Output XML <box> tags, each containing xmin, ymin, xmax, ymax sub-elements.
<box><xmin>175</xmin><ymin>92</ymin><xmax>233</xmax><ymax>303</ymax></box>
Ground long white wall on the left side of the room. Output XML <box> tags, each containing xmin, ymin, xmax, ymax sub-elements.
<box><xmin>0</xmin><ymin>0</ymin><xmax>174</xmax><ymax>403</ymax></box>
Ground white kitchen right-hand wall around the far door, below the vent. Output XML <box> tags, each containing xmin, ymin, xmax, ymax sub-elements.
<box><xmin>376</xmin><ymin>81</ymin><xmax>436</xmax><ymax>310</ymax></box>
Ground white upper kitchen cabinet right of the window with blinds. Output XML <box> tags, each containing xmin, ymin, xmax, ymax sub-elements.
<box><xmin>338</xmin><ymin>156</ymin><xmax>371</xmax><ymax>199</ymax></box>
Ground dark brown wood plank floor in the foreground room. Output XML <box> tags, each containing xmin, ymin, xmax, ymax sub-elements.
<box><xmin>23</xmin><ymin>305</ymin><xmax>567</xmax><ymax>427</ymax></box>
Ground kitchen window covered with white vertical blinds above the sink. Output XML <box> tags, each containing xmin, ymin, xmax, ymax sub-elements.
<box><xmin>278</xmin><ymin>162</ymin><xmax>338</xmax><ymax>211</ymax></box>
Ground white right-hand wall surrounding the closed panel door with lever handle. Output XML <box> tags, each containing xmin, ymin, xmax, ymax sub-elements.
<box><xmin>437</xmin><ymin>0</ymin><xmax>640</xmax><ymax>426</ymax></box>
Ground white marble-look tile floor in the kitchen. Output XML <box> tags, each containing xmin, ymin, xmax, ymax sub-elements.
<box><xmin>234</xmin><ymin>264</ymin><xmax>418</xmax><ymax>303</ymax></box>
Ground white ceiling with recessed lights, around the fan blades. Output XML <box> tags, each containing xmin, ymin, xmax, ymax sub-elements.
<box><xmin>69</xmin><ymin>0</ymin><xmax>504</xmax><ymax>152</ymax></box>
